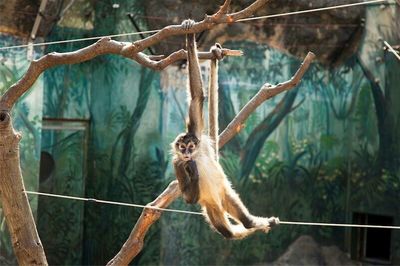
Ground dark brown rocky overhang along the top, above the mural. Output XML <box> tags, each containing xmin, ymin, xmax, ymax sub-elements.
<box><xmin>142</xmin><ymin>0</ymin><xmax>366</xmax><ymax>65</ymax></box>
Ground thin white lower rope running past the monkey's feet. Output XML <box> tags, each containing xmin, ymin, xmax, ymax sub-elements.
<box><xmin>25</xmin><ymin>191</ymin><xmax>400</xmax><ymax>230</ymax></box>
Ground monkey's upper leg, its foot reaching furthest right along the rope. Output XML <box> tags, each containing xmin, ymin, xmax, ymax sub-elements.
<box><xmin>224</xmin><ymin>188</ymin><xmax>279</xmax><ymax>232</ymax></box>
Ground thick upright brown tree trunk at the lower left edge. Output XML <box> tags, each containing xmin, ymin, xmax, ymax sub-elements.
<box><xmin>0</xmin><ymin>111</ymin><xmax>47</xmax><ymax>265</ymax></box>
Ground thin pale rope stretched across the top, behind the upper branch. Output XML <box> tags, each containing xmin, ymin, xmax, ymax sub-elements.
<box><xmin>0</xmin><ymin>0</ymin><xmax>390</xmax><ymax>51</ymax></box>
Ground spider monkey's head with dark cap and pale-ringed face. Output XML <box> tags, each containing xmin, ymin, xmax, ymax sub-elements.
<box><xmin>172</xmin><ymin>133</ymin><xmax>200</xmax><ymax>161</ymax></box>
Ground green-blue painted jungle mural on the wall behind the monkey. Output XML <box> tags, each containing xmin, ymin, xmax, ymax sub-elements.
<box><xmin>0</xmin><ymin>1</ymin><xmax>400</xmax><ymax>265</ymax></box>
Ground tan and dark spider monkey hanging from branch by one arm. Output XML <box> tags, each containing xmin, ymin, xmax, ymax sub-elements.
<box><xmin>171</xmin><ymin>19</ymin><xmax>279</xmax><ymax>239</ymax></box>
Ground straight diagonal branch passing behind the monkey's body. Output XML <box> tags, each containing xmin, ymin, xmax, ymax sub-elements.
<box><xmin>107</xmin><ymin>52</ymin><xmax>315</xmax><ymax>266</ymax></box>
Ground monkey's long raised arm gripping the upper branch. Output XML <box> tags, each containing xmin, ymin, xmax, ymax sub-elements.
<box><xmin>182</xmin><ymin>20</ymin><xmax>204</xmax><ymax>139</ymax></box>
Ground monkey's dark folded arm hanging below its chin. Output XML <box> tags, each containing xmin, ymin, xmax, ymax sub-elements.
<box><xmin>173</xmin><ymin>161</ymin><xmax>200</xmax><ymax>204</ymax></box>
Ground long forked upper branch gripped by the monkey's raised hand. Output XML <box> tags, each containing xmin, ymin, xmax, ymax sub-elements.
<box><xmin>0</xmin><ymin>0</ymin><xmax>268</xmax><ymax>110</ymax></box>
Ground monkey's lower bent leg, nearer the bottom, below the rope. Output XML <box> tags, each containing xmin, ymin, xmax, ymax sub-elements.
<box><xmin>206</xmin><ymin>205</ymin><xmax>256</xmax><ymax>239</ymax></box>
